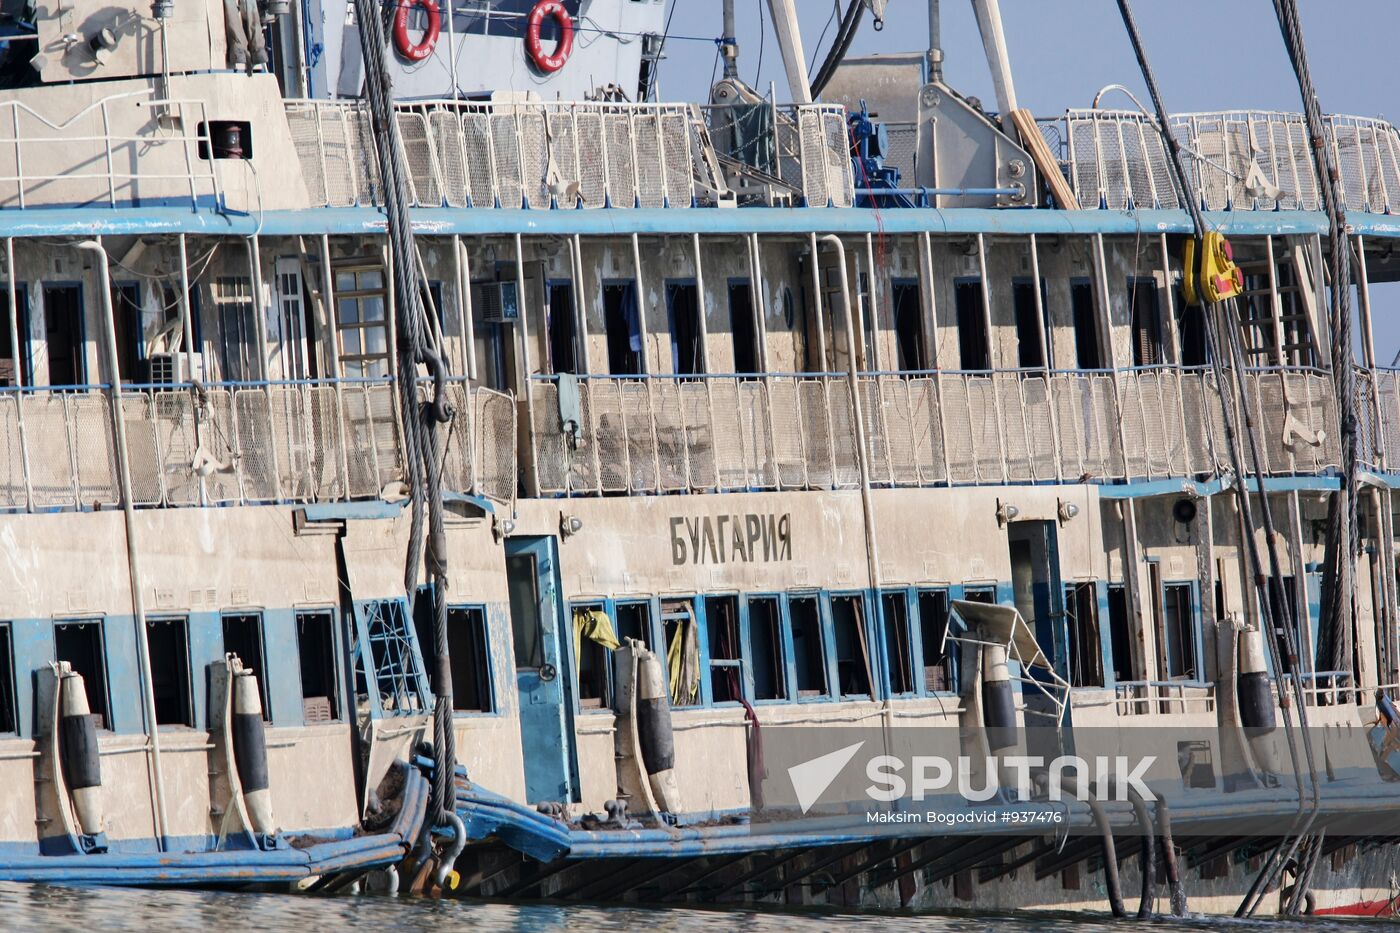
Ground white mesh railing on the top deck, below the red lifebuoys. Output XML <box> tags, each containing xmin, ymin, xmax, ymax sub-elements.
<box><xmin>286</xmin><ymin>101</ymin><xmax>854</xmax><ymax>209</ymax></box>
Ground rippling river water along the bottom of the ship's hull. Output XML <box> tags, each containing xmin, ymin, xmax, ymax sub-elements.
<box><xmin>0</xmin><ymin>884</ymin><xmax>1400</xmax><ymax>933</ymax></box>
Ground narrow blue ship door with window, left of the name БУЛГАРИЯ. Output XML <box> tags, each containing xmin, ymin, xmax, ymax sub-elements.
<box><xmin>505</xmin><ymin>538</ymin><xmax>577</xmax><ymax>804</ymax></box>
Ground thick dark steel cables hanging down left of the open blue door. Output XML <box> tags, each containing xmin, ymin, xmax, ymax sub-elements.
<box><xmin>354</xmin><ymin>0</ymin><xmax>456</xmax><ymax>846</ymax></box>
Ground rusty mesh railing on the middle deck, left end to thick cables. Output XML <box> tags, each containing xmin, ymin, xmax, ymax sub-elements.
<box><xmin>0</xmin><ymin>381</ymin><xmax>517</xmax><ymax>509</ymax></box>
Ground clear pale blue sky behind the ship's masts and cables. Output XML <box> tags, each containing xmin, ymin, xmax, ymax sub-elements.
<box><xmin>659</xmin><ymin>0</ymin><xmax>1400</xmax><ymax>363</ymax></box>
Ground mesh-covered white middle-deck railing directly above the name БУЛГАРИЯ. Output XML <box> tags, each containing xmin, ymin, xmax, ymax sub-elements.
<box><xmin>531</xmin><ymin>368</ymin><xmax>1340</xmax><ymax>495</ymax></box>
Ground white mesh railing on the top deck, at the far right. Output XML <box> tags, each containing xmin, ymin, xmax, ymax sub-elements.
<box><xmin>1042</xmin><ymin>108</ymin><xmax>1400</xmax><ymax>213</ymax></box>
